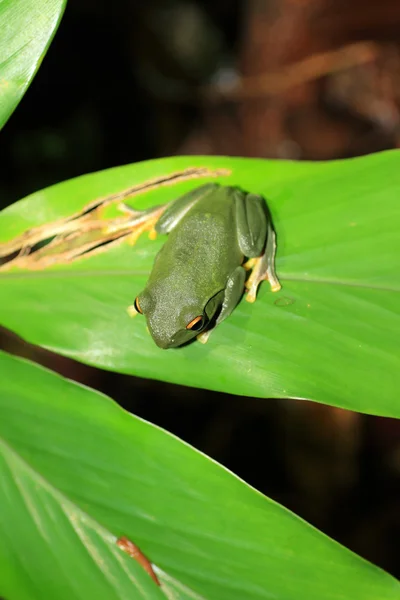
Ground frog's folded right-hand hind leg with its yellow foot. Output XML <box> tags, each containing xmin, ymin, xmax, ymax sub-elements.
<box><xmin>235</xmin><ymin>191</ymin><xmax>281</xmax><ymax>302</ymax></box>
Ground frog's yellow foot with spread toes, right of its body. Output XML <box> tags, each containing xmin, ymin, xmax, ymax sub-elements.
<box><xmin>243</xmin><ymin>226</ymin><xmax>281</xmax><ymax>302</ymax></box>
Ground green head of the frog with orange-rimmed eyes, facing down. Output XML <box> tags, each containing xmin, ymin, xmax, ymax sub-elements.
<box><xmin>134</xmin><ymin>290</ymin><xmax>224</xmax><ymax>348</ymax></box>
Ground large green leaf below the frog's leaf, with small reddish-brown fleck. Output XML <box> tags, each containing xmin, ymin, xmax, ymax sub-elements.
<box><xmin>0</xmin><ymin>353</ymin><xmax>400</xmax><ymax>600</ymax></box>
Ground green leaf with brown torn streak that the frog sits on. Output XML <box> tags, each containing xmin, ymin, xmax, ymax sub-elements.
<box><xmin>0</xmin><ymin>151</ymin><xmax>400</xmax><ymax>417</ymax></box>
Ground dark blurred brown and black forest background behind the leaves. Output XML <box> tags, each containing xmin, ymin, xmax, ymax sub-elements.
<box><xmin>0</xmin><ymin>0</ymin><xmax>400</xmax><ymax>577</ymax></box>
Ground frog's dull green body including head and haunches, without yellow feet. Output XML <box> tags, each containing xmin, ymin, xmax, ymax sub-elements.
<box><xmin>136</xmin><ymin>183</ymin><xmax>271</xmax><ymax>348</ymax></box>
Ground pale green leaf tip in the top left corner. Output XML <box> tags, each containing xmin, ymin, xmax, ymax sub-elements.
<box><xmin>0</xmin><ymin>0</ymin><xmax>66</xmax><ymax>129</ymax></box>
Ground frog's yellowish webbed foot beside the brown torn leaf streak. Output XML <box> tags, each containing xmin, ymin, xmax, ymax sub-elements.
<box><xmin>106</xmin><ymin>202</ymin><xmax>168</xmax><ymax>246</ymax></box>
